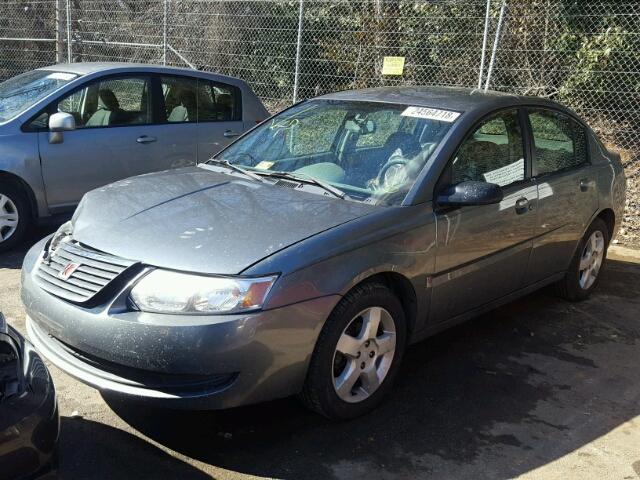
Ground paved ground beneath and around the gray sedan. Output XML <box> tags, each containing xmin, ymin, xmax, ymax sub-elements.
<box><xmin>0</xmin><ymin>230</ymin><xmax>640</xmax><ymax>479</ymax></box>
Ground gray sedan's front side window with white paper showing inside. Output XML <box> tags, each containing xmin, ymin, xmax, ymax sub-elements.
<box><xmin>452</xmin><ymin>110</ymin><xmax>526</xmax><ymax>187</ymax></box>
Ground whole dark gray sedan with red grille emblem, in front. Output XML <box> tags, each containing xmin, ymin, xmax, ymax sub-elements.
<box><xmin>22</xmin><ymin>87</ymin><xmax>625</xmax><ymax>418</ymax></box>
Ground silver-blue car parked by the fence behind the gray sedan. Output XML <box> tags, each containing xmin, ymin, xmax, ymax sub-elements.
<box><xmin>0</xmin><ymin>63</ymin><xmax>269</xmax><ymax>252</ymax></box>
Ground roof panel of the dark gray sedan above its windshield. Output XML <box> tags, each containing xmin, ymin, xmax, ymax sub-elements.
<box><xmin>318</xmin><ymin>86</ymin><xmax>540</xmax><ymax>111</ymax></box>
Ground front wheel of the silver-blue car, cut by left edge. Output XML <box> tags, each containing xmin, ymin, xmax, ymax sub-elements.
<box><xmin>0</xmin><ymin>181</ymin><xmax>30</xmax><ymax>252</ymax></box>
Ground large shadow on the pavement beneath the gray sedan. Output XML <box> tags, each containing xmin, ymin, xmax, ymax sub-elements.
<box><xmin>105</xmin><ymin>261</ymin><xmax>640</xmax><ymax>479</ymax></box>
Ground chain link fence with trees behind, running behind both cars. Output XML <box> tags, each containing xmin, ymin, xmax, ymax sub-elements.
<box><xmin>0</xmin><ymin>0</ymin><xmax>640</xmax><ymax>240</ymax></box>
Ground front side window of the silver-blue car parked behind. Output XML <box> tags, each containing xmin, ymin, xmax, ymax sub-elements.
<box><xmin>56</xmin><ymin>77</ymin><xmax>151</xmax><ymax>128</ymax></box>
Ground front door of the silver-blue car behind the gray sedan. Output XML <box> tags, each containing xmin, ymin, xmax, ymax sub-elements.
<box><xmin>38</xmin><ymin>75</ymin><xmax>195</xmax><ymax>212</ymax></box>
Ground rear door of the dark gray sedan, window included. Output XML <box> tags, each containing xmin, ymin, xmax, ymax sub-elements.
<box><xmin>527</xmin><ymin>108</ymin><xmax>598</xmax><ymax>283</ymax></box>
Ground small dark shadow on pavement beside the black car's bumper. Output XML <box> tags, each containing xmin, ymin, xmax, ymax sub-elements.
<box><xmin>58</xmin><ymin>417</ymin><xmax>211</xmax><ymax>480</ymax></box>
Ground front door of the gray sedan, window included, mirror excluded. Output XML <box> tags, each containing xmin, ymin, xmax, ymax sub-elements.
<box><xmin>430</xmin><ymin>109</ymin><xmax>537</xmax><ymax>322</ymax></box>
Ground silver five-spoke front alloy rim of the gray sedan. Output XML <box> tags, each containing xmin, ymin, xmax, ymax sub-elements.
<box><xmin>333</xmin><ymin>307</ymin><xmax>396</xmax><ymax>403</ymax></box>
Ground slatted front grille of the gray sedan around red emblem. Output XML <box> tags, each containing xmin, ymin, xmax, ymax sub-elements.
<box><xmin>37</xmin><ymin>242</ymin><xmax>135</xmax><ymax>303</ymax></box>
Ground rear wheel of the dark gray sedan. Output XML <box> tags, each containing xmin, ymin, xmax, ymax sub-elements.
<box><xmin>556</xmin><ymin>218</ymin><xmax>609</xmax><ymax>302</ymax></box>
